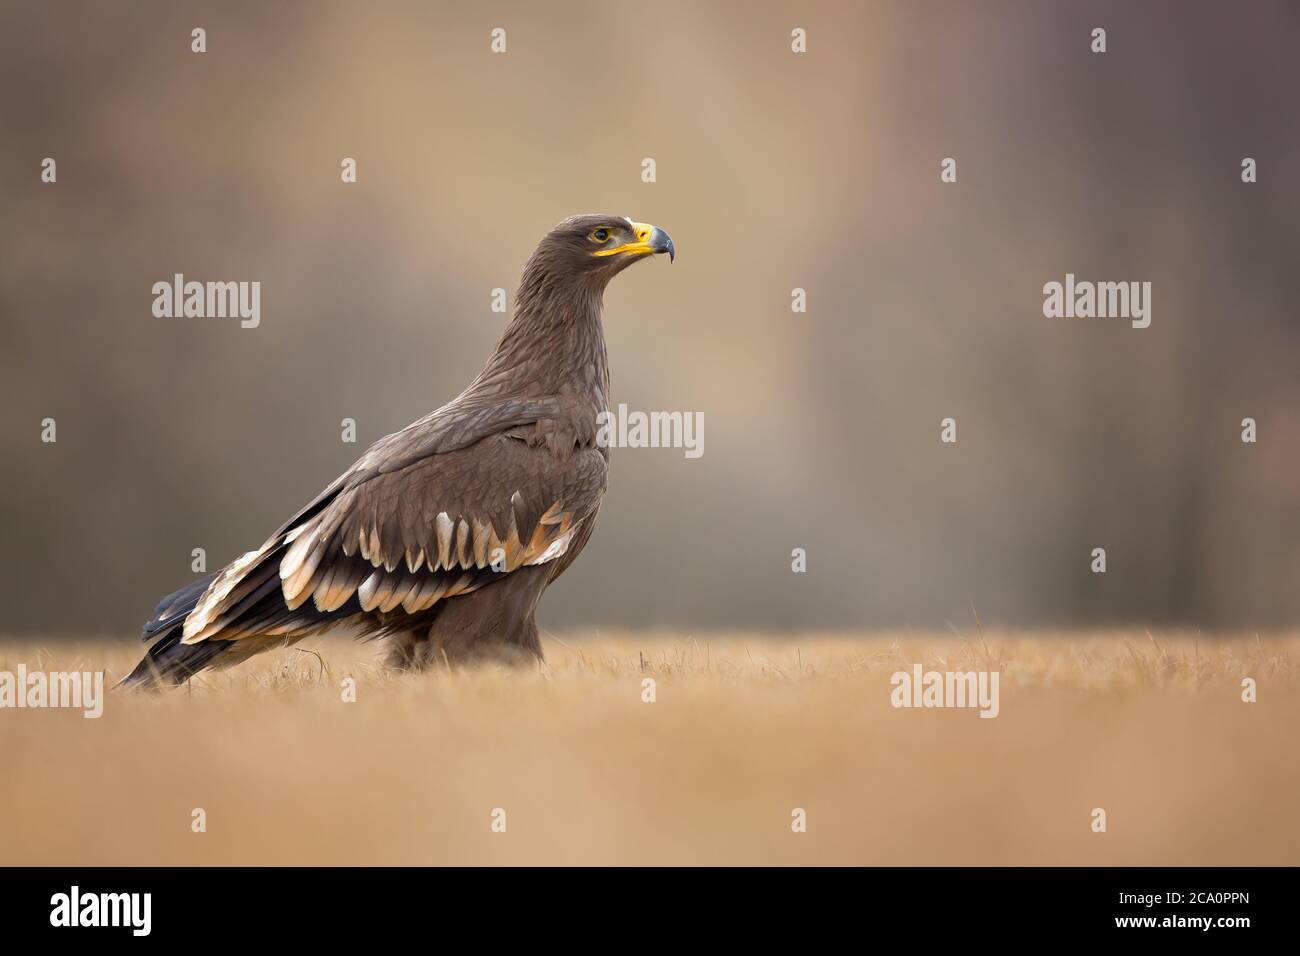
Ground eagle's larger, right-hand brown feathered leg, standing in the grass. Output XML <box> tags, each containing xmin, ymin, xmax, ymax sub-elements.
<box><xmin>426</xmin><ymin>566</ymin><xmax>551</xmax><ymax>666</ymax></box>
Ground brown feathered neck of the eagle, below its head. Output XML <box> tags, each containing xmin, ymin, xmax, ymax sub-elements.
<box><xmin>477</xmin><ymin>263</ymin><xmax>610</xmax><ymax>411</ymax></box>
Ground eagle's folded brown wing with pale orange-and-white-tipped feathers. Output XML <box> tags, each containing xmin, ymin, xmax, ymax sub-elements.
<box><xmin>156</xmin><ymin>403</ymin><xmax>607</xmax><ymax>655</ymax></box>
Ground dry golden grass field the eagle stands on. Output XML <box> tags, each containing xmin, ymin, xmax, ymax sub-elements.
<box><xmin>0</xmin><ymin>630</ymin><xmax>1300</xmax><ymax>865</ymax></box>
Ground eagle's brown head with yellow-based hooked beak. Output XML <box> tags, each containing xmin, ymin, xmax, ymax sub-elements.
<box><xmin>533</xmin><ymin>216</ymin><xmax>677</xmax><ymax>287</ymax></box>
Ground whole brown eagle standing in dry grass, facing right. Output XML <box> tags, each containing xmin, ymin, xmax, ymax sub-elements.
<box><xmin>122</xmin><ymin>216</ymin><xmax>676</xmax><ymax>687</ymax></box>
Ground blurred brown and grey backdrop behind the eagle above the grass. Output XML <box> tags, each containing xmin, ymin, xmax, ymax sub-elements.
<box><xmin>0</xmin><ymin>0</ymin><xmax>1300</xmax><ymax>635</ymax></box>
